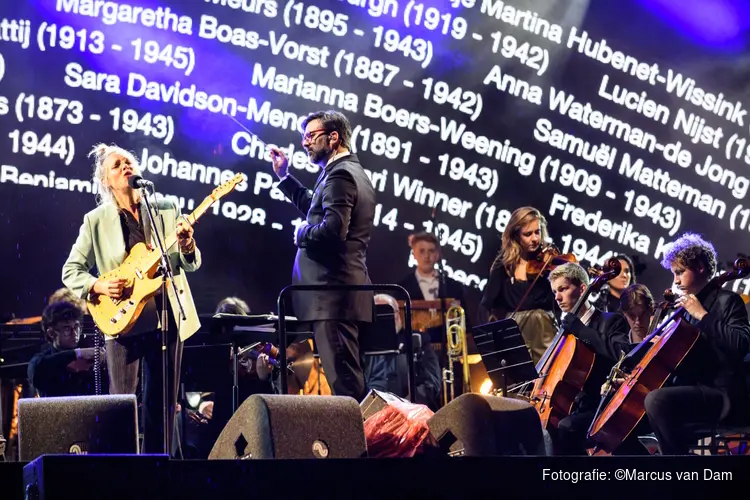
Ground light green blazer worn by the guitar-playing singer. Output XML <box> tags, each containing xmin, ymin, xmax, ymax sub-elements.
<box><xmin>62</xmin><ymin>198</ymin><xmax>201</xmax><ymax>342</ymax></box>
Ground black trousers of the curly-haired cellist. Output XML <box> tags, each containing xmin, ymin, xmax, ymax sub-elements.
<box><xmin>645</xmin><ymin>385</ymin><xmax>730</xmax><ymax>455</ymax></box>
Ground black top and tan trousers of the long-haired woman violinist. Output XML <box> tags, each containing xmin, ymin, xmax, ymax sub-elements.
<box><xmin>480</xmin><ymin>265</ymin><xmax>557</xmax><ymax>364</ymax></box>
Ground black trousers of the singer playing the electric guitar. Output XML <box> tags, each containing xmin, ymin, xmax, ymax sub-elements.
<box><xmin>107</xmin><ymin>310</ymin><xmax>182</xmax><ymax>454</ymax></box>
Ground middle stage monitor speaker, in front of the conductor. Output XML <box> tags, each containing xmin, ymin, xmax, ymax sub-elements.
<box><xmin>208</xmin><ymin>394</ymin><xmax>367</xmax><ymax>459</ymax></box>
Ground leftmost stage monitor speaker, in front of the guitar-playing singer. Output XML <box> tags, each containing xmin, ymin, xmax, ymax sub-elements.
<box><xmin>18</xmin><ymin>394</ymin><xmax>138</xmax><ymax>462</ymax></box>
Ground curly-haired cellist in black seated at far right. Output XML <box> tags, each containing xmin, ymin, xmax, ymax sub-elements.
<box><xmin>645</xmin><ymin>233</ymin><xmax>750</xmax><ymax>455</ymax></box>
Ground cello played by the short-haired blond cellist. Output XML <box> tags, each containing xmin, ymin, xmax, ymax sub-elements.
<box><xmin>529</xmin><ymin>258</ymin><xmax>622</xmax><ymax>428</ymax></box>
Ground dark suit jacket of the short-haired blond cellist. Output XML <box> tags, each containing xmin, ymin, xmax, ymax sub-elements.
<box><xmin>570</xmin><ymin>309</ymin><xmax>630</xmax><ymax>412</ymax></box>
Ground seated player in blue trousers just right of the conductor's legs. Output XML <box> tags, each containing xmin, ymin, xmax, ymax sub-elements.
<box><xmin>364</xmin><ymin>294</ymin><xmax>442</xmax><ymax>411</ymax></box>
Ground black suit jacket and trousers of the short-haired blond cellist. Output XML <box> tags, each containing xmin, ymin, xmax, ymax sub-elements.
<box><xmin>551</xmin><ymin>308</ymin><xmax>648</xmax><ymax>455</ymax></box>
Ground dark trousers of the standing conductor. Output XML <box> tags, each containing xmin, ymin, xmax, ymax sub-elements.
<box><xmin>313</xmin><ymin>321</ymin><xmax>367</xmax><ymax>402</ymax></box>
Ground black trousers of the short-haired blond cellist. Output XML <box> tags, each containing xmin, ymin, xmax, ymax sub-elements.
<box><xmin>551</xmin><ymin>411</ymin><xmax>649</xmax><ymax>455</ymax></box>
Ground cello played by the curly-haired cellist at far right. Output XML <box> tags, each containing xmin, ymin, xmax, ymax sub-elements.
<box><xmin>587</xmin><ymin>258</ymin><xmax>750</xmax><ymax>454</ymax></box>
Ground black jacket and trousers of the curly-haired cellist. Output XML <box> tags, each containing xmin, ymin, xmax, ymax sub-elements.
<box><xmin>645</xmin><ymin>289</ymin><xmax>750</xmax><ymax>455</ymax></box>
